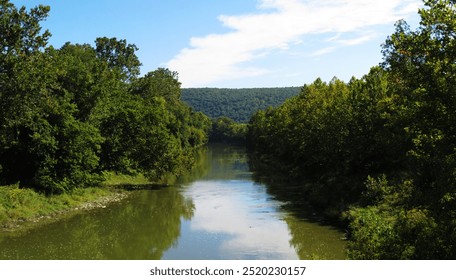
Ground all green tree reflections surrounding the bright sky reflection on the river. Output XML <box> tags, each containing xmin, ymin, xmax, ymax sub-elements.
<box><xmin>0</xmin><ymin>146</ymin><xmax>345</xmax><ymax>259</ymax></box>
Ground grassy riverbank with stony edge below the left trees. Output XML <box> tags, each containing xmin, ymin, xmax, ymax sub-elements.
<box><xmin>0</xmin><ymin>173</ymin><xmax>149</xmax><ymax>231</ymax></box>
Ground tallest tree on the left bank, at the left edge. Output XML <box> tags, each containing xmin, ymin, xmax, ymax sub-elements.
<box><xmin>0</xmin><ymin>1</ymin><xmax>101</xmax><ymax>192</ymax></box>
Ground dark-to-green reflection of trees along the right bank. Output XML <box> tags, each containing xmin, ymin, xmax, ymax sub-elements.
<box><xmin>249</xmin><ymin>154</ymin><xmax>346</xmax><ymax>260</ymax></box>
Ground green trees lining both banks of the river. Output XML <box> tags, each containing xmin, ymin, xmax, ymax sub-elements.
<box><xmin>0</xmin><ymin>0</ymin><xmax>456</xmax><ymax>259</ymax></box>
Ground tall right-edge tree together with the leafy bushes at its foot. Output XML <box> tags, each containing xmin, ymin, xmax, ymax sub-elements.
<box><xmin>350</xmin><ymin>0</ymin><xmax>456</xmax><ymax>259</ymax></box>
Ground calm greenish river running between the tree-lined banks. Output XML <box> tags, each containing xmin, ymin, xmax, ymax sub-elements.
<box><xmin>0</xmin><ymin>145</ymin><xmax>346</xmax><ymax>260</ymax></box>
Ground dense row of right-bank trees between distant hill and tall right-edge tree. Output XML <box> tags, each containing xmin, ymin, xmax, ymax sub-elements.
<box><xmin>249</xmin><ymin>73</ymin><xmax>397</xmax><ymax>213</ymax></box>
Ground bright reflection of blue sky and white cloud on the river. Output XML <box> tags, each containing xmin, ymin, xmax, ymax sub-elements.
<box><xmin>164</xmin><ymin>180</ymin><xmax>297</xmax><ymax>259</ymax></box>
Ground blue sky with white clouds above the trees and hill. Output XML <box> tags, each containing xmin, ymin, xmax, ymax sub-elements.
<box><xmin>11</xmin><ymin>0</ymin><xmax>423</xmax><ymax>88</ymax></box>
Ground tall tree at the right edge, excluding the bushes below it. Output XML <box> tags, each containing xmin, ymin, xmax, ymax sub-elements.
<box><xmin>383</xmin><ymin>1</ymin><xmax>456</xmax><ymax>203</ymax></box>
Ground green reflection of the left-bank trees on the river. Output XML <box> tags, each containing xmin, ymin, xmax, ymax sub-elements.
<box><xmin>0</xmin><ymin>187</ymin><xmax>195</xmax><ymax>259</ymax></box>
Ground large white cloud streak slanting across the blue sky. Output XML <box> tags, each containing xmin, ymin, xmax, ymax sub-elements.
<box><xmin>166</xmin><ymin>0</ymin><xmax>421</xmax><ymax>87</ymax></box>
